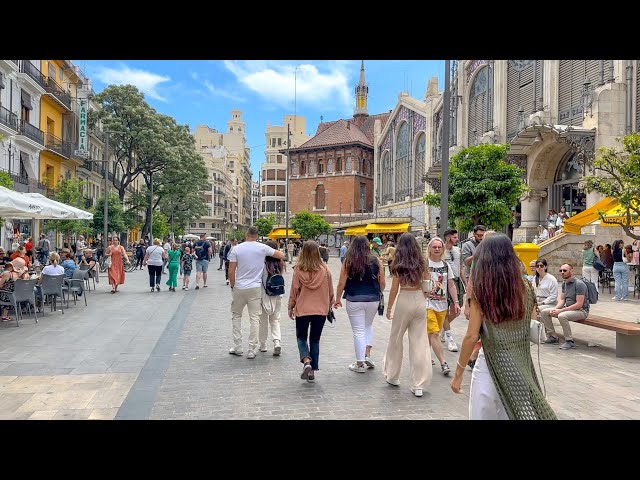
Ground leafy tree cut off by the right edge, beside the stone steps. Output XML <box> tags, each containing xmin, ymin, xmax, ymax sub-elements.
<box><xmin>586</xmin><ymin>132</ymin><xmax>640</xmax><ymax>240</ymax></box>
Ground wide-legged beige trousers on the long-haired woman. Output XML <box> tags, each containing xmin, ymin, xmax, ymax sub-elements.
<box><xmin>383</xmin><ymin>289</ymin><xmax>433</xmax><ymax>389</ymax></box>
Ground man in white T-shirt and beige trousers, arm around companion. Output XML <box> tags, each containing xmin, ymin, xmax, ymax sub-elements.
<box><xmin>227</xmin><ymin>227</ymin><xmax>284</xmax><ymax>359</ymax></box>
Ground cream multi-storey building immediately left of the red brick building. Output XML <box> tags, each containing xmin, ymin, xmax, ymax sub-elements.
<box><xmin>260</xmin><ymin>115</ymin><xmax>311</xmax><ymax>220</ymax></box>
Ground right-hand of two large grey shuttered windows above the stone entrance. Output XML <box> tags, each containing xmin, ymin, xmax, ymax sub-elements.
<box><xmin>558</xmin><ymin>60</ymin><xmax>608</xmax><ymax>126</ymax></box>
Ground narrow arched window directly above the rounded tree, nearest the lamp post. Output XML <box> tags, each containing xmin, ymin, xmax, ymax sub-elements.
<box><xmin>468</xmin><ymin>66</ymin><xmax>493</xmax><ymax>145</ymax></box>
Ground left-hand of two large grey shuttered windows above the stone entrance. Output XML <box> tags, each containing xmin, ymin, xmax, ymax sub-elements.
<box><xmin>507</xmin><ymin>60</ymin><xmax>543</xmax><ymax>141</ymax></box>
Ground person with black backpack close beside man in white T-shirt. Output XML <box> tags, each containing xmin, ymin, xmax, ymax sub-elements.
<box><xmin>258</xmin><ymin>240</ymin><xmax>287</xmax><ymax>356</ymax></box>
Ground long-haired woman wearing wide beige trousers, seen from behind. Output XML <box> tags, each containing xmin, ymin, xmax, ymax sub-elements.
<box><xmin>383</xmin><ymin>232</ymin><xmax>432</xmax><ymax>397</ymax></box>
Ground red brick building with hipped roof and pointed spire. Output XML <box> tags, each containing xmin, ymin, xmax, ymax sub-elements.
<box><xmin>282</xmin><ymin>62</ymin><xmax>389</xmax><ymax>223</ymax></box>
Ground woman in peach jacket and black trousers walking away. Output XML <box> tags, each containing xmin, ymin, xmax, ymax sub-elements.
<box><xmin>289</xmin><ymin>240</ymin><xmax>334</xmax><ymax>382</ymax></box>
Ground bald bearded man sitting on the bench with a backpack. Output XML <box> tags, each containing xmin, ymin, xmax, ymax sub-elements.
<box><xmin>540</xmin><ymin>263</ymin><xmax>589</xmax><ymax>350</ymax></box>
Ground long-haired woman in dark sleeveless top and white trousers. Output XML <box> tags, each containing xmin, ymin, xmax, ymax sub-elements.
<box><xmin>334</xmin><ymin>235</ymin><xmax>385</xmax><ymax>373</ymax></box>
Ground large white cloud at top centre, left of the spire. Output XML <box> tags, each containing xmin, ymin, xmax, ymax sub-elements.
<box><xmin>224</xmin><ymin>60</ymin><xmax>352</xmax><ymax>110</ymax></box>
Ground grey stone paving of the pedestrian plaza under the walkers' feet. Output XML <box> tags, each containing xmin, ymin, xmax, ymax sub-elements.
<box><xmin>0</xmin><ymin>257</ymin><xmax>640</xmax><ymax>420</ymax></box>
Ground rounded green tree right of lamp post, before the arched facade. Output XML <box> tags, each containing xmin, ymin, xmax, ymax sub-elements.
<box><xmin>423</xmin><ymin>144</ymin><xmax>527</xmax><ymax>231</ymax></box>
